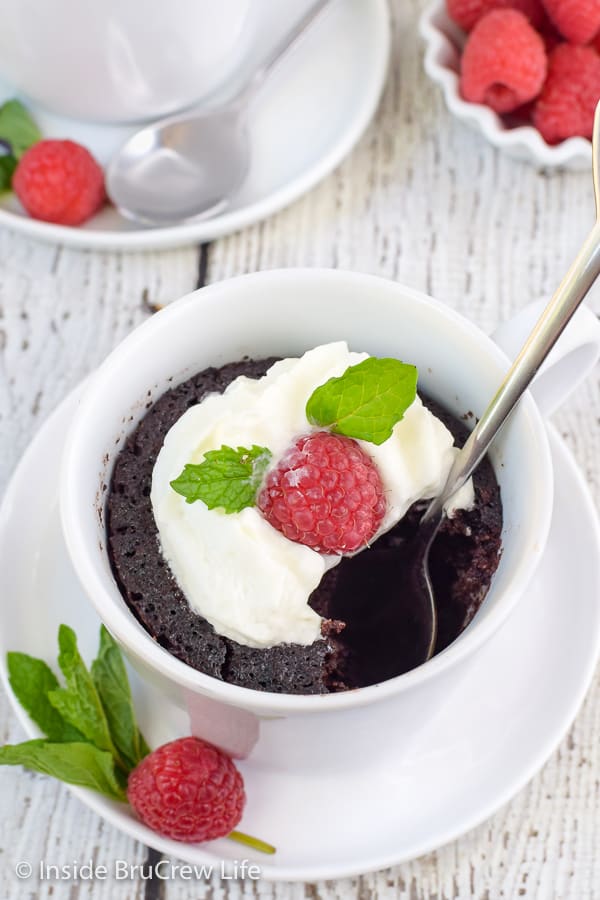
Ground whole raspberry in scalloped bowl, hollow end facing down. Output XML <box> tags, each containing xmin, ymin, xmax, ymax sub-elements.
<box><xmin>460</xmin><ymin>9</ymin><xmax>547</xmax><ymax>113</ymax></box>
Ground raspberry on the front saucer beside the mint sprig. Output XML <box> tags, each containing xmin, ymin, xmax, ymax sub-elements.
<box><xmin>127</xmin><ymin>737</ymin><xmax>246</xmax><ymax>843</ymax></box>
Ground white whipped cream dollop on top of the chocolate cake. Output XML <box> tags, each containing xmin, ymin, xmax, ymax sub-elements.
<box><xmin>151</xmin><ymin>342</ymin><xmax>474</xmax><ymax>647</ymax></box>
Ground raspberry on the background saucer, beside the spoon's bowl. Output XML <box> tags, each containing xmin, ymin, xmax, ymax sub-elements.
<box><xmin>13</xmin><ymin>140</ymin><xmax>106</xmax><ymax>225</ymax></box>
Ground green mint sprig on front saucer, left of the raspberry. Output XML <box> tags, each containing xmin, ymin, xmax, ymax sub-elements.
<box><xmin>0</xmin><ymin>625</ymin><xmax>150</xmax><ymax>801</ymax></box>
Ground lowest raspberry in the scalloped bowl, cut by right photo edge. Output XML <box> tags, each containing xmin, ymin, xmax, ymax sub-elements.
<box><xmin>533</xmin><ymin>44</ymin><xmax>600</xmax><ymax>144</ymax></box>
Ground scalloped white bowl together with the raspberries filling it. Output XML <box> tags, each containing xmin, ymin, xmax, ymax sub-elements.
<box><xmin>419</xmin><ymin>0</ymin><xmax>600</xmax><ymax>171</ymax></box>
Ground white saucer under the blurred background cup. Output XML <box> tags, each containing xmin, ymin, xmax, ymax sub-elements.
<box><xmin>0</xmin><ymin>0</ymin><xmax>390</xmax><ymax>250</ymax></box>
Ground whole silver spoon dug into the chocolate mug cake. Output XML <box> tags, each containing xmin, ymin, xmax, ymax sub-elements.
<box><xmin>331</xmin><ymin>103</ymin><xmax>600</xmax><ymax>684</ymax></box>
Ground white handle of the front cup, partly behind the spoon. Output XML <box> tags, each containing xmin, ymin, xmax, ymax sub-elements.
<box><xmin>492</xmin><ymin>299</ymin><xmax>600</xmax><ymax>416</ymax></box>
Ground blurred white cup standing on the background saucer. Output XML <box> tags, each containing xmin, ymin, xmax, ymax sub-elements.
<box><xmin>0</xmin><ymin>0</ymin><xmax>255</xmax><ymax>123</ymax></box>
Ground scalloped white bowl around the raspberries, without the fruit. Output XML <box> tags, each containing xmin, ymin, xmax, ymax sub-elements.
<box><xmin>419</xmin><ymin>0</ymin><xmax>592</xmax><ymax>171</ymax></box>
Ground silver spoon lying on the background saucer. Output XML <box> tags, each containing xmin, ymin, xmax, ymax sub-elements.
<box><xmin>106</xmin><ymin>0</ymin><xmax>331</xmax><ymax>225</ymax></box>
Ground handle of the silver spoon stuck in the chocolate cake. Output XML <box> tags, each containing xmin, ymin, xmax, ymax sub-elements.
<box><xmin>423</xmin><ymin>103</ymin><xmax>600</xmax><ymax>521</ymax></box>
